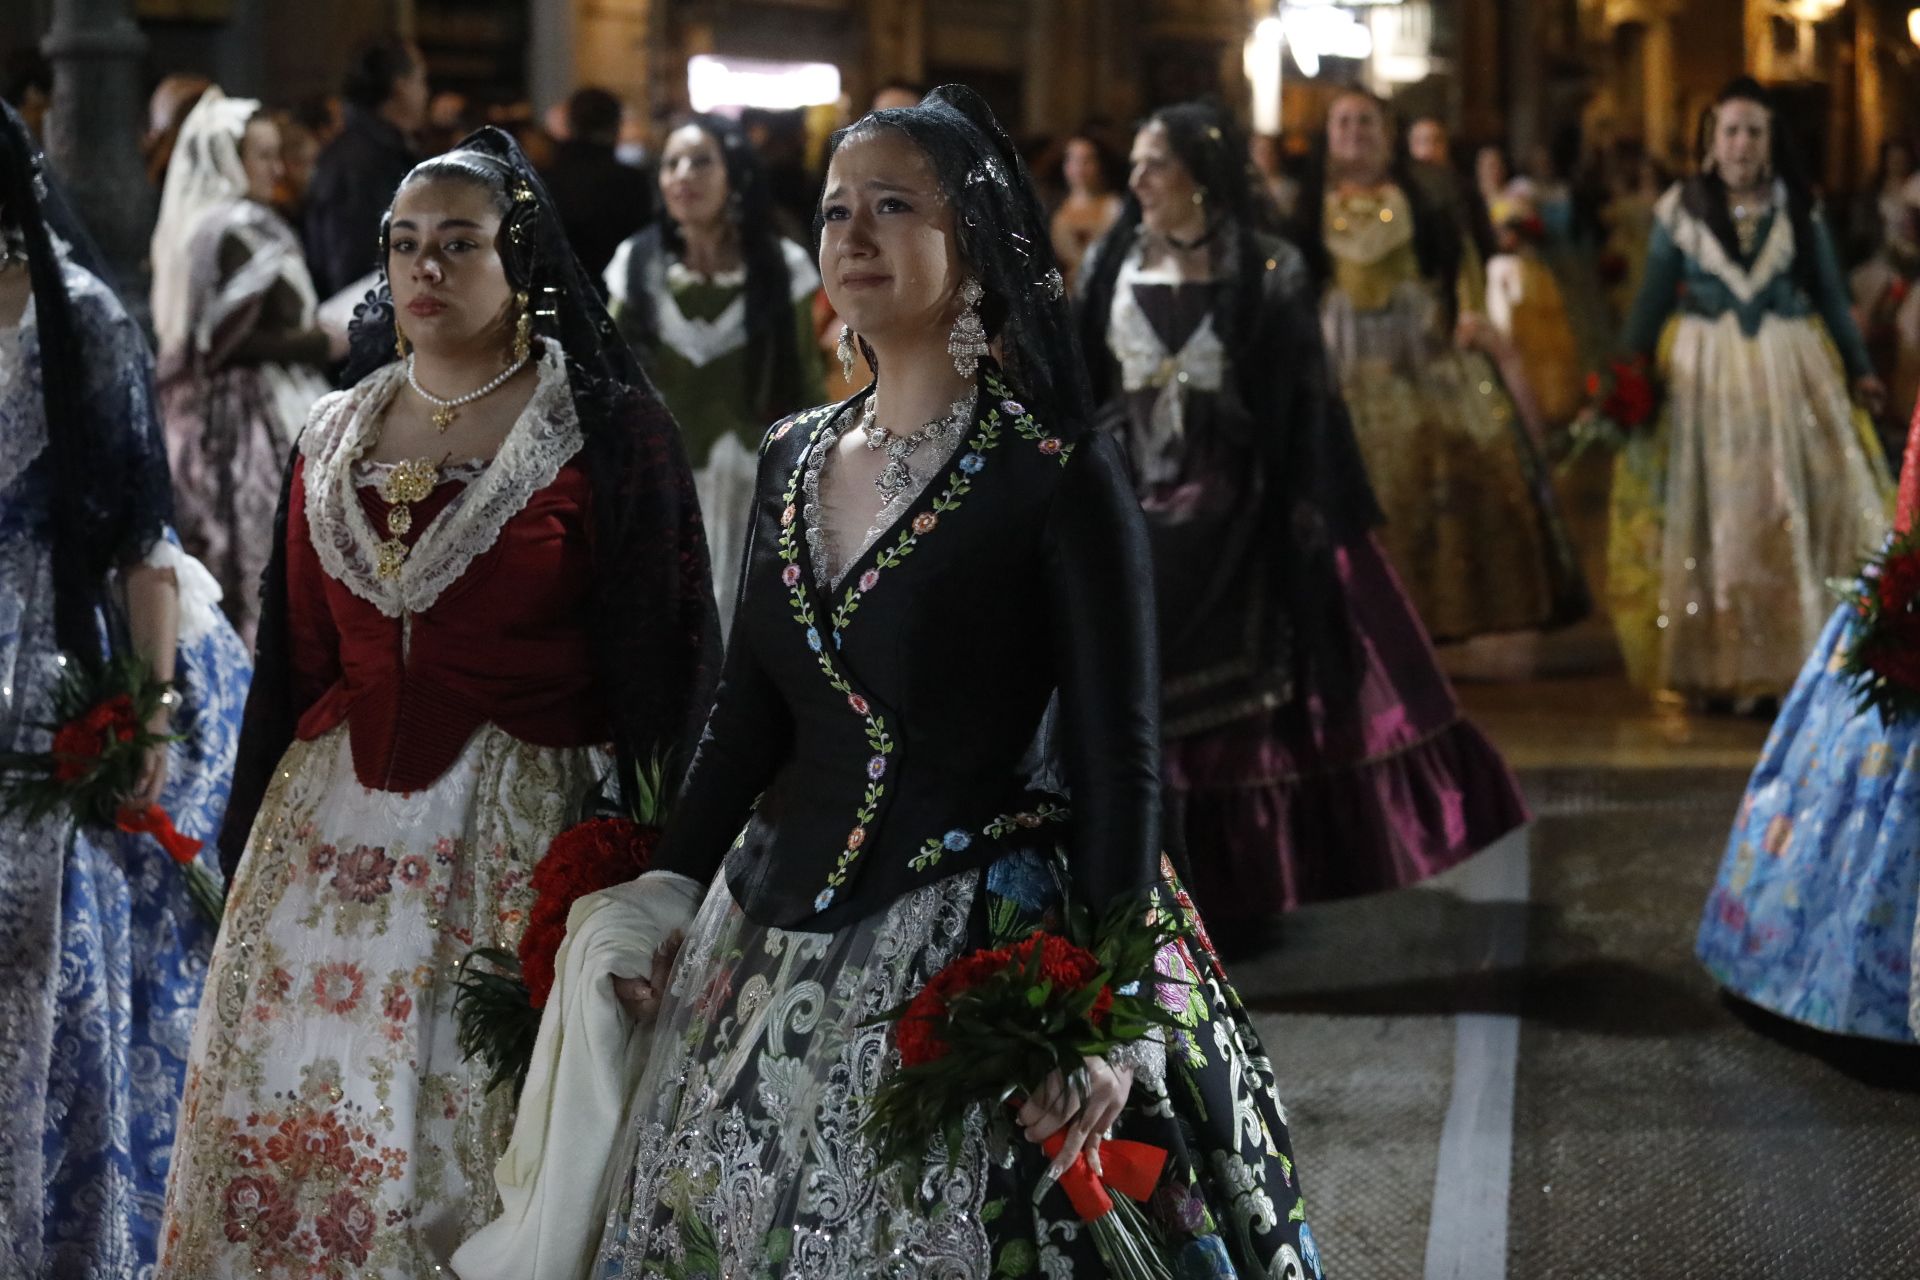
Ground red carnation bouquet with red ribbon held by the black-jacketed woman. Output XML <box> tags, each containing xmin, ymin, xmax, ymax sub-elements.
<box><xmin>866</xmin><ymin>904</ymin><xmax>1181</xmax><ymax>1280</ymax></box>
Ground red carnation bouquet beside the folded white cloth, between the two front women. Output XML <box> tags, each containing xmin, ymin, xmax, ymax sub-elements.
<box><xmin>453</xmin><ymin>760</ymin><xmax>666</xmax><ymax>1092</ymax></box>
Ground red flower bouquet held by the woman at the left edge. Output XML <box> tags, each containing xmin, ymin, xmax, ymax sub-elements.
<box><xmin>0</xmin><ymin>654</ymin><xmax>227</xmax><ymax>925</ymax></box>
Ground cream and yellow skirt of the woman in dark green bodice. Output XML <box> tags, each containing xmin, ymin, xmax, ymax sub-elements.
<box><xmin>1607</xmin><ymin>315</ymin><xmax>1891</xmax><ymax>697</ymax></box>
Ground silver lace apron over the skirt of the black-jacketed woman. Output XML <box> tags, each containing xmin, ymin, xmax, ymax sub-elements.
<box><xmin>591</xmin><ymin>875</ymin><xmax>993</xmax><ymax>1280</ymax></box>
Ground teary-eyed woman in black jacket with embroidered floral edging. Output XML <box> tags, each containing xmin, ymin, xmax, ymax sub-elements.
<box><xmin>474</xmin><ymin>86</ymin><xmax>1319</xmax><ymax>1280</ymax></box>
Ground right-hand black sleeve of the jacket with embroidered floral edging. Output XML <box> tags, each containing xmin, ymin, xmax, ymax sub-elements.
<box><xmin>1044</xmin><ymin>432</ymin><xmax>1160</xmax><ymax>913</ymax></box>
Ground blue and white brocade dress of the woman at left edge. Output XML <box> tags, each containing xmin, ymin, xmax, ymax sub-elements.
<box><xmin>0</xmin><ymin>267</ymin><xmax>252</xmax><ymax>1276</ymax></box>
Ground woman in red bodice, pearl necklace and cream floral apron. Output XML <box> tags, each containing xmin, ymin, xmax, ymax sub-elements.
<box><xmin>159</xmin><ymin>130</ymin><xmax>718</xmax><ymax>1280</ymax></box>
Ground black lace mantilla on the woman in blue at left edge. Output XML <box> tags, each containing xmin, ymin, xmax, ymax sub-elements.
<box><xmin>0</xmin><ymin>102</ymin><xmax>173</xmax><ymax>662</ymax></box>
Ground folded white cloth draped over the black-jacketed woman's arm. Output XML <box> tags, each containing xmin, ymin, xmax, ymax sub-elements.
<box><xmin>451</xmin><ymin>871</ymin><xmax>705</xmax><ymax>1280</ymax></box>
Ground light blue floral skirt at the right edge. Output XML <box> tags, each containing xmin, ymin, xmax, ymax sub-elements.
<box><xmin>1697</xmin><ymin>606</ymin><xmax>1920</xmax><ymax>1042</ymax></box>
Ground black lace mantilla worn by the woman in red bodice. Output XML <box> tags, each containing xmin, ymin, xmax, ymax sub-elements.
<box><xmin>221</xmin><ymin>127</ymin><xmax>720</xmax><ymax>875</ymax></box>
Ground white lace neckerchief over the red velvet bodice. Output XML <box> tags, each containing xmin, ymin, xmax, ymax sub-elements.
<box><xmin>300</xmin><ymin>340</ymin><xmax>584</xmax><ymax>618</ymax></box>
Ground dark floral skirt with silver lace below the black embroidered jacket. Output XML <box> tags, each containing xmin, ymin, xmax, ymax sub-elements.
<box><xmin>595</xmin><ymin>852</ymin><xmax>1321</xmax><ymax>1280</ymax></box>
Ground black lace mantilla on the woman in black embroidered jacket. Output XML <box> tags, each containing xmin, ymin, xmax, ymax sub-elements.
<box><xmin>814</xmin><ymin>84</ymin><xmax>1092</xmax><ymax>438</ymax></box>
